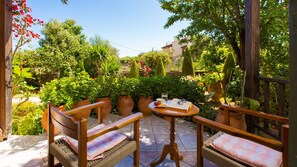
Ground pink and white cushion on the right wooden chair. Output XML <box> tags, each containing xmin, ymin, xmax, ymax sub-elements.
<box><xmin>210</xmin><ymin>133</ymin><xmax>282</xmax><ymax>167</ymax></box>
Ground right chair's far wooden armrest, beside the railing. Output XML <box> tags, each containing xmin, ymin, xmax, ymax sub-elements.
<box><xmin>221</xmin><ymin>104</ymin><xmax>289</xmax><ymax>124</ymax></box>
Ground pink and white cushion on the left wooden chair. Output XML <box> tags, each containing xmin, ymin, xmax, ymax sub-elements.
<box><xmin>64</xmin><ymin>124</ymin><xmax>127</xmax><ymax>160</ymax></box>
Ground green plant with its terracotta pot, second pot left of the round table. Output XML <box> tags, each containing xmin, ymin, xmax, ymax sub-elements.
<box><xmin>117</xmin><ymin>77</ymin><xmax>138</xmax><ymax>116</ymax></box>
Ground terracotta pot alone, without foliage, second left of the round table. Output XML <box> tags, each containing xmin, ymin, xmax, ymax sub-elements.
<box><xmin>118</xmin><ymin>96</ymin><xmax>134</xmax><ymax>116</ymax></box>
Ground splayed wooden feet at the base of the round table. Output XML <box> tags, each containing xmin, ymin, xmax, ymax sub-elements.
<box><xmin>150</xmin><ymin>143</ymin><xmax>183</xmax><ymax>167</ymax></box>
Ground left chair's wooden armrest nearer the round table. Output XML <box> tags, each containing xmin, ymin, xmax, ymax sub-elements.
<box><xmin>87</xmin><ymin>113</ymin><xmax>143</xmax><ymax>142</ymax></box>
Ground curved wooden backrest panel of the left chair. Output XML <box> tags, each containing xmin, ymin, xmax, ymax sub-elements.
<box><xmin>50</xmin><ymin>107</ymin><xmax>78</xmax><ymax>139</ymax></box>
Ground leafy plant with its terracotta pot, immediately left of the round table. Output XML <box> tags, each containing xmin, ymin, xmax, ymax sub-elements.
<box><xmin>137</xmin><ymin>77</ymin><xmax>154</xmax><ymax>116</ymax></box>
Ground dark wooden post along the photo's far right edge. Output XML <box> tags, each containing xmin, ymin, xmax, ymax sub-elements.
<box><xmin>289</xmin><ymin>0</ymin><xmax>297</xmax><ymax>166</ymax></box>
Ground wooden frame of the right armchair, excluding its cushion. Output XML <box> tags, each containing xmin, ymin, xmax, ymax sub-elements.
<box><xmin>193</xmin><ymin>105</ymin><xmax>289</xmax><ymax>167</ymax></box>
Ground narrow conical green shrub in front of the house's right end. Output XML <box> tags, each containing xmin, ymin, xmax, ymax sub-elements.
<box><xmin>182</xmin><ymin>48</ymin><xmax>195</xmax><ymax>77</ymax></box>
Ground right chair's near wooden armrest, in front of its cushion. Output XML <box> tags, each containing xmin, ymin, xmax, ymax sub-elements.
<box><xmin>193</xmin><ymin>116</ymin><xmax>283</xmax><ymax>152</ymax></box>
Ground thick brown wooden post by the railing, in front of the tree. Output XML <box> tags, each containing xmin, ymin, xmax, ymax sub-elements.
<box><xmin>244</xmin><ymin>0</ymin><xmax>260</xmax><ymax>99</ymax></box>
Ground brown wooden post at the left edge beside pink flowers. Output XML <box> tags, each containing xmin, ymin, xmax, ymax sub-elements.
<box><xmin>0</xmin><ymin>0</ymin><xmax>12</xmax><ymax>139</ymax></box>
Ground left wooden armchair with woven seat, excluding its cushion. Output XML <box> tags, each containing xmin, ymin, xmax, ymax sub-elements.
<box><xmin>48</xmin><ymin>102</ymin><xmax>143</xmax><ymax>167</ymax></box>
